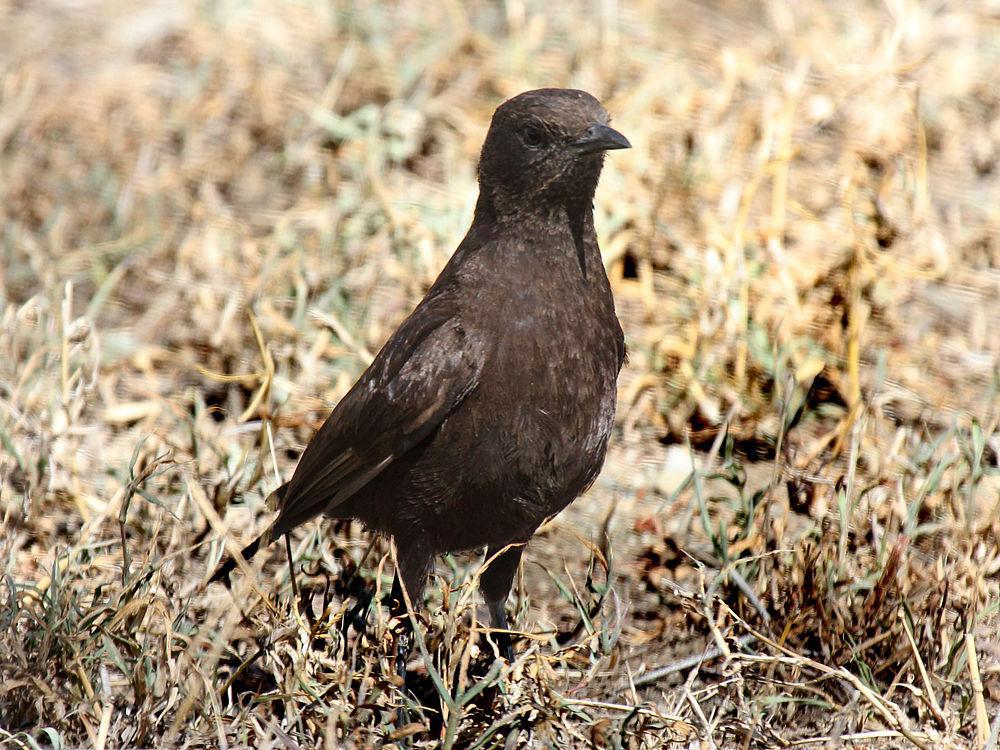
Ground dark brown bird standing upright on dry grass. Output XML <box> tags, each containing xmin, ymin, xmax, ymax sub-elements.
<box><xmin>212</xmin><ymin>89</ymin><xmax>630</xmax><ymax>657</ymax></box>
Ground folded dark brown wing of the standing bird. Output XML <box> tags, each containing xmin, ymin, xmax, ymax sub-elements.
<box><xmin>269</xmin><ymin>296</ymin><xmax>485</xmax><ymax>539</ymax></box>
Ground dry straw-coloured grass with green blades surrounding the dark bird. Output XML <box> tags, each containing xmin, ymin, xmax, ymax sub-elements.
<box><xmin>0</xmin><ymin>0</ymin><xmax>1000</xmax><ymax>748</ymax></box>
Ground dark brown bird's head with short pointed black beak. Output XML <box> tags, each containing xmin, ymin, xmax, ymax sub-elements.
<box><xmin>479</xmin><ymin>89</ymin><xmax>631</xmax><ymax>215</ymax></box>
